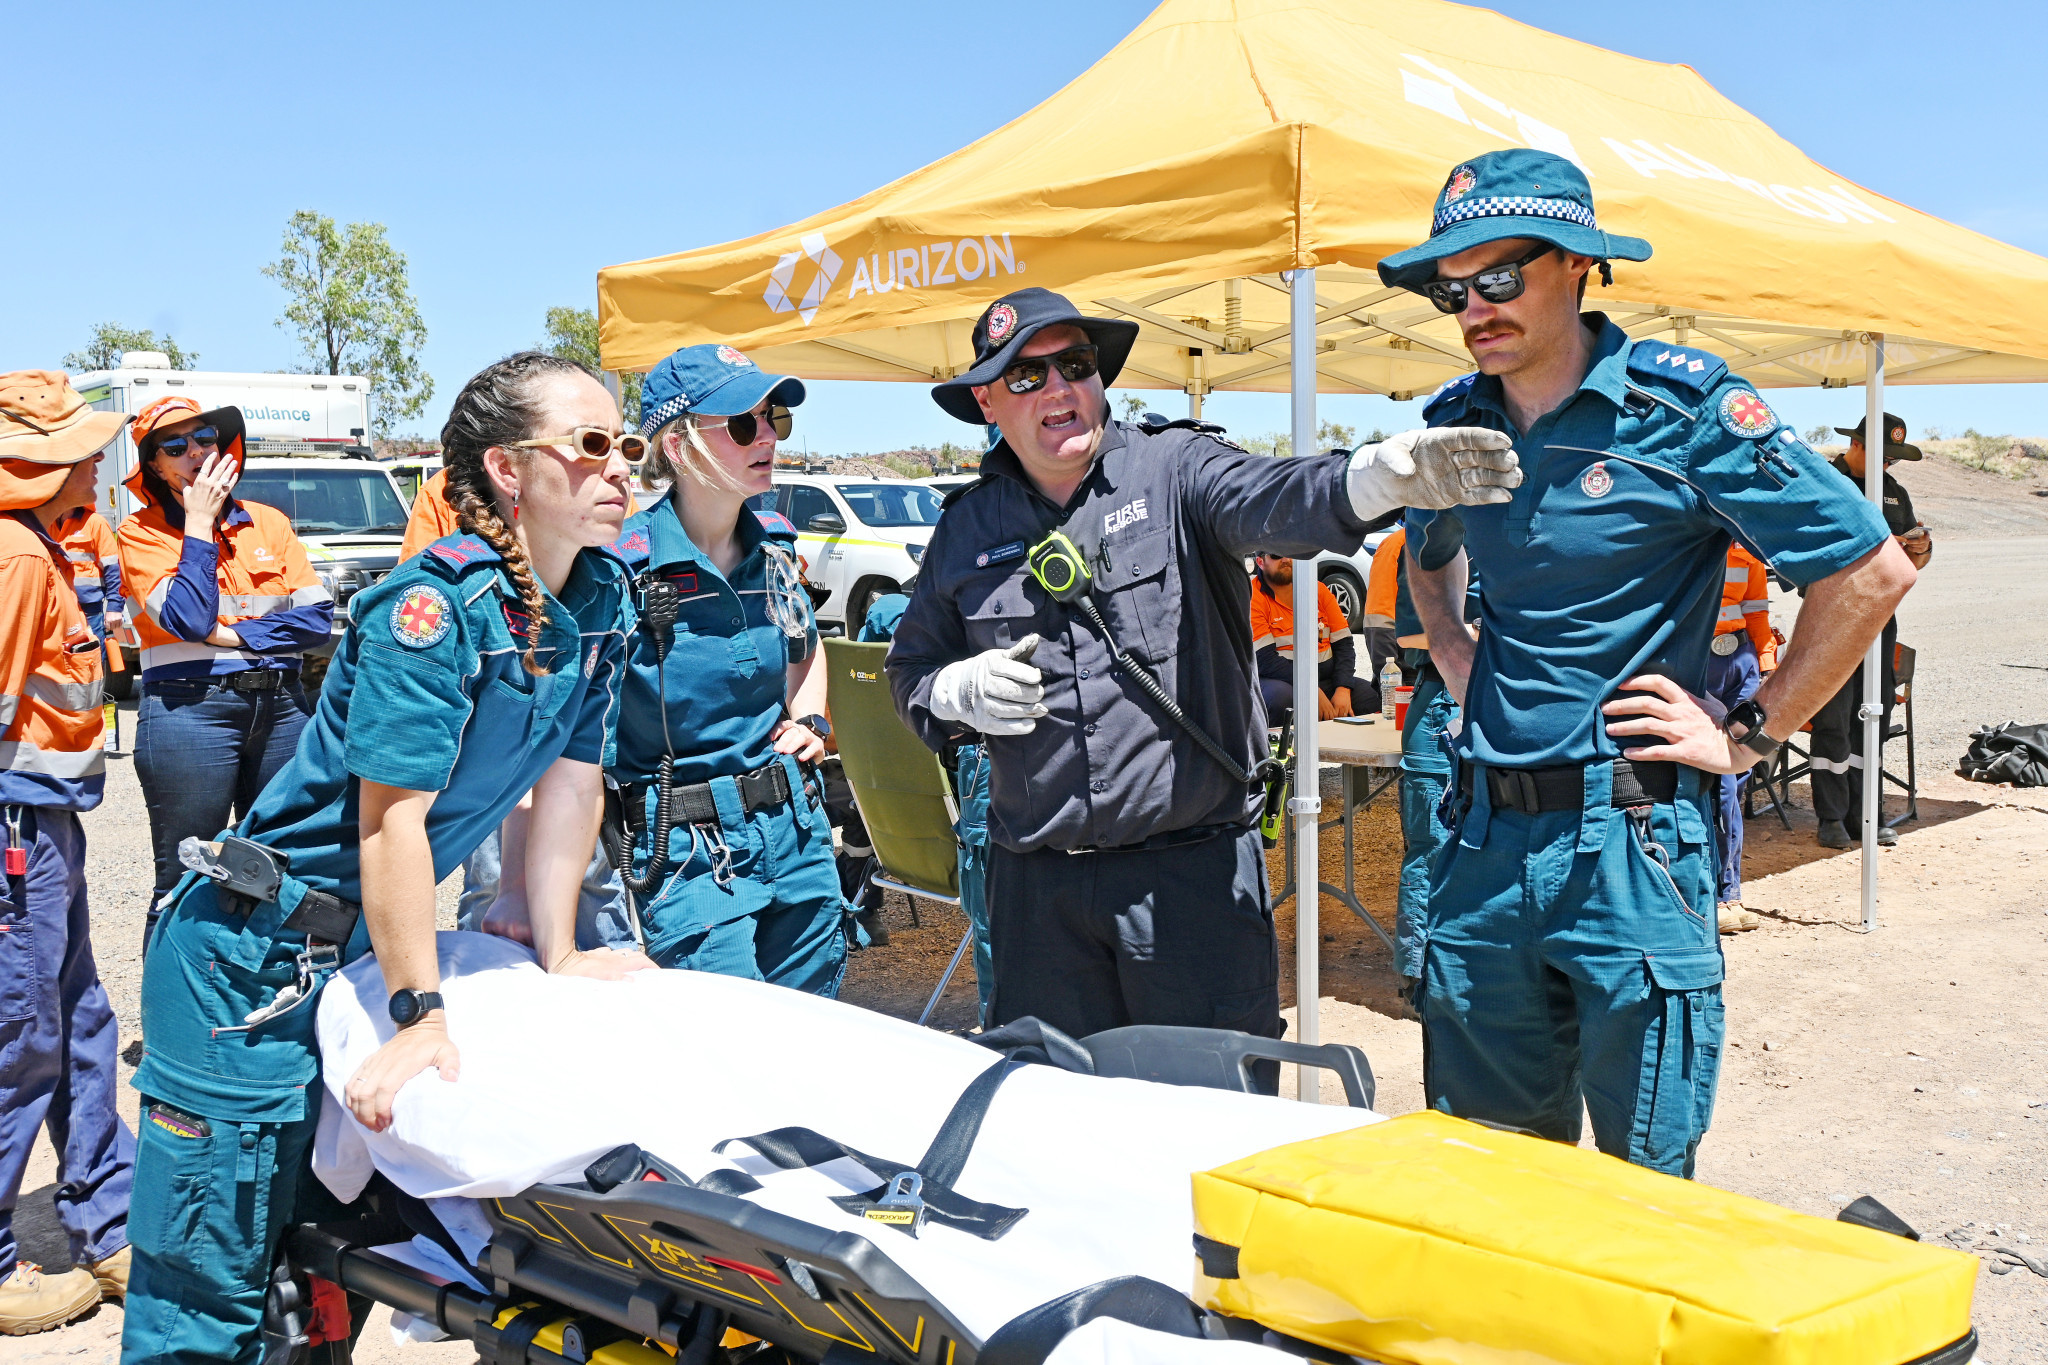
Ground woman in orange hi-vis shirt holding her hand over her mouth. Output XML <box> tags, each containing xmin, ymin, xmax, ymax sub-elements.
<box><xmin>117</xmin><ymin>397</ymin><xmax>334</xmax><ymax>952</ymax></box>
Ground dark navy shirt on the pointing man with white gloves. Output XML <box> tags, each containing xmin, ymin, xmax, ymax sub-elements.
<box><xmin>887</xmin><ymin>422</ymin><xmax>1366</xmax><ymax>853</ymax></box>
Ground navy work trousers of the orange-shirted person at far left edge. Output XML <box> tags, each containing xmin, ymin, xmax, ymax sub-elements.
<box><xmin>0</xmin><ymin>806</ymin><xmax>135</xmax><ymax>1277</ymax></box>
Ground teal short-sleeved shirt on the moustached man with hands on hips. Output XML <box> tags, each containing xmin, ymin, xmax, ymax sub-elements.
<box><xmin>1407</xmin><ymin>313</ymin><xmax>1890</xmax><ymax>767</ymax></box>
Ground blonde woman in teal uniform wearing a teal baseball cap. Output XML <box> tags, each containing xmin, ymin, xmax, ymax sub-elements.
<box><xmin>612</xmin><ymin>346</ymin><xmax>848</xmax><ymax>995</ymax></box>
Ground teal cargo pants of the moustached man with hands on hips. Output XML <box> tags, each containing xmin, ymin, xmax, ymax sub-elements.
<box><xmin>1417</xmin><ymin>763</ymin><xmax>1724</xmax><ymax>1177</ymax></box>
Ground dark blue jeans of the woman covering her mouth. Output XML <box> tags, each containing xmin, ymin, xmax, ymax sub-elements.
<box><xmin>135</xmin><ymin>673</ymin><xmax>311</xmax><ymax>952</ymax></box>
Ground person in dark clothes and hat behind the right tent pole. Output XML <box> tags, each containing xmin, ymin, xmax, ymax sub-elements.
<box><xmin>1812</xmin><ymin>413</ymin><xmax>1933</xmax><ymax>849</ymax></box>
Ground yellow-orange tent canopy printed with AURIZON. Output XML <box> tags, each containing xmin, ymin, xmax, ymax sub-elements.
<box><xmin>598</xmin><ymin>0</ymin><xmax>2048</xmax><ymax>399</ymax></box>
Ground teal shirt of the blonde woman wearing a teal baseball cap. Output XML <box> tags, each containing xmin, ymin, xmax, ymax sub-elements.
<box><xmin>610</xmin><ymin>497</ymin><xmax>817</xmax><ymax>786</ymax></box>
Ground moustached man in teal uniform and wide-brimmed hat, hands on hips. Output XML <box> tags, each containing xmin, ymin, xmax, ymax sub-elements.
<box><xmin>1380</xmin><ymin>149</ymin><xmax>1913</xmax><ymax>1175</ymax></box>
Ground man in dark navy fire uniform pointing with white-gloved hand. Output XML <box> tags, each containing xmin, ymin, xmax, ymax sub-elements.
<box><xmin>887</xmin><ymin>289</ymin><xmax>1520</xmax><ymax>1038</ymax></box>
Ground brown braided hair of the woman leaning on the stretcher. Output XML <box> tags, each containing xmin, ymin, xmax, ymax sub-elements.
<box><xmin>440</xmin><ymin>350</ymin><xmax>592</xmax><ymax>675</ymax></box>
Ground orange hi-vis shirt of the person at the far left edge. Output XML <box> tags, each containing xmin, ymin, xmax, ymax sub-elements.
<box><xmin>0</xmin><ymin>512</ymin><xmax>106</xmax><ymax>810</ymax></box>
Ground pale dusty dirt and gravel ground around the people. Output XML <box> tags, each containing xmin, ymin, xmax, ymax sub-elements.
<box><xmin>16</xmin><ymin>460</ymin><xmax>2048</xmax><ymax>1365</ymax></box>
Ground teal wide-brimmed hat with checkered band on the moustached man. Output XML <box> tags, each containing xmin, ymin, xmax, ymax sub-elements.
<box><xmin>1380</xmin><ymin>147</ymin><xmax>1651</xmax><ymax>289</ymax></box>
